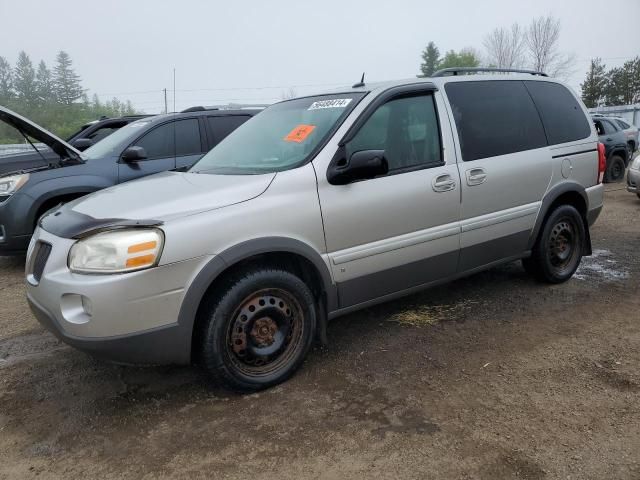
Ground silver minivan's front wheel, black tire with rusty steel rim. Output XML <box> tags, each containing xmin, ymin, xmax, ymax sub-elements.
<box><xmin>200</xmin><ymin>269</ymin><xmax>317</xmax><ymax>392</ymax></box>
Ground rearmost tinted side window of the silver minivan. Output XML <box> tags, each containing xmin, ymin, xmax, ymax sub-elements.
<box><xmin>525</xmin><ymin>81</ymin><xmax>591</xmax><ymax>145</ymax></box>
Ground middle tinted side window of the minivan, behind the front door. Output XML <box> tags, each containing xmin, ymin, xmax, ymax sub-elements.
<box><xmin>445</xmin><ymin>81</ymin><xmax>547</xmax><ymax>162</ymax></box>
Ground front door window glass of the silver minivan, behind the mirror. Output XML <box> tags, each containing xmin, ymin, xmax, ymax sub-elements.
<box><xmin>347</xmin><ymin>95</ymin><xmax>442</xmax><ymax>171</ymax></box>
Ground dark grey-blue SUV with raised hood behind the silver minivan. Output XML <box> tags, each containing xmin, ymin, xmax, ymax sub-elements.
<box><xmin>0</xmin><ymin>107</ymin><xmax>261</xmax><ymax>255</ymax></box>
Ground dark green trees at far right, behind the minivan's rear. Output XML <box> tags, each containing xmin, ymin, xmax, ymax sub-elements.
<box><xmin>581</xmin><ymin>56</ymin><xmax>640</xmax><ymax>108</ymax></box>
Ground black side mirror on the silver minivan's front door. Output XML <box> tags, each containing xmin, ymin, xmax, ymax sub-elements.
<box><xmin>327</xmin><ymin>150</ymin><xmax>389</xmax><ymax>185</ymax></box>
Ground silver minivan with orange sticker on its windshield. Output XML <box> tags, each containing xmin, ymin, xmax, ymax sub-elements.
<box><xmin>26</xmin><ymin>69</ymin><xmax>605</xmax><ymax>391</ymax></box>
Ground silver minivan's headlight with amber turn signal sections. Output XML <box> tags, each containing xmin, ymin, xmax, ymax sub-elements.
<box><xmin>69</xmin><ymin>228</ymin><xmax>164</xmax><ymax>273</ymax></box>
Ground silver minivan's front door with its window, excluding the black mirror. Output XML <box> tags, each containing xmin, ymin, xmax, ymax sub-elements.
<box><xmin>318</xmin><ymin>87</ymin><xmax>460</xmax><ymax>308</ymax></box>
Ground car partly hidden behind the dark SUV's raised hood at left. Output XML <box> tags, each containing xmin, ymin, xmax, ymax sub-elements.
<box><xmin>0</xmin><ymin>112</ymin><xmax>149</xmax><ymax>175</ymax></box>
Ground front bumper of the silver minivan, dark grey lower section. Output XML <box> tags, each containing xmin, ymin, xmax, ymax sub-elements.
<box><xmin>26</xmin><ymin>229</ymin><xmax>211</xmax><ymax>365</ymax></box>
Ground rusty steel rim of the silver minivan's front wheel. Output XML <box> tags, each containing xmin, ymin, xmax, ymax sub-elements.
<box><xmin>226</xmin><ymin>288</ymin><xmax>305</xmax><ymax>377</ymax></box>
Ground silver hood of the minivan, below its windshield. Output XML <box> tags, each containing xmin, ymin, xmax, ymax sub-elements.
<box><xmin>71</xmin><ymin>172</ymin><xmax>276</xmax><ymax>221</ymax></box>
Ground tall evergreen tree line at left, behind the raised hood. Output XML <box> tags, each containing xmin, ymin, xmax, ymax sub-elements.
<box><xmin>0</xmin><ymin>51</ymin><xmax>137</xmax><ymax>143</ymax></box>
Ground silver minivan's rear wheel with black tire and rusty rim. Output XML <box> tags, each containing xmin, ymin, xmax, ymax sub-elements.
<box><xmin>522</xmin><ymin>205</ymin><xmax>586</xmax><ymax>283</ymax></box>
